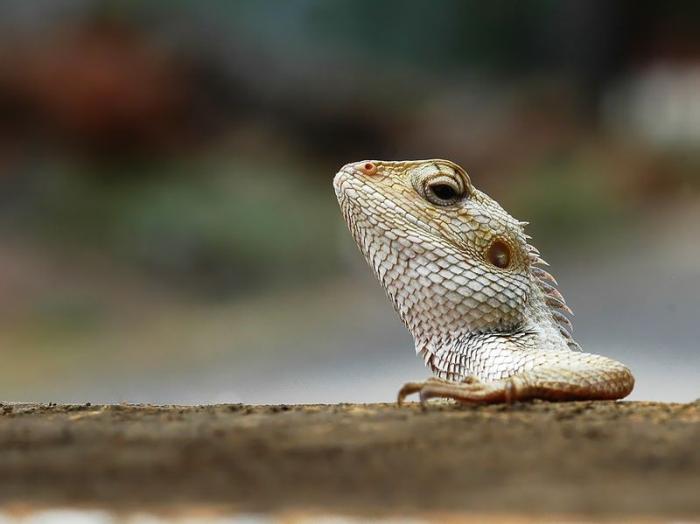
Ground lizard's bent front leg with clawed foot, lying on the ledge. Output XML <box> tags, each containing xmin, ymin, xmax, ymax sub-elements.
<box><xmin>398</xmin><ymin>352</ymin><xmax>634</xmax><ymax>404</ymax></box>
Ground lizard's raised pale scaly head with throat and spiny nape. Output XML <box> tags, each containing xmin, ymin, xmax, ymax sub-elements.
<box><xmin>334</xmin><ymin>160</ymin><xmax>575</xmax><ymax>364</ymax></box>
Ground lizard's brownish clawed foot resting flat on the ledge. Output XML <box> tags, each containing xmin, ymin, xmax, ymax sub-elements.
<box><xmin>397</xmin><ymin>377</ymin><xmax>517</xmax><ymax>406</ymax></box>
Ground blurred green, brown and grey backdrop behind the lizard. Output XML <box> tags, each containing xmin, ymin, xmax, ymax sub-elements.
<box><xmin>0</xmin><ymin>0</ymin><xmax>700</xmax><ymax>403</ymax></box>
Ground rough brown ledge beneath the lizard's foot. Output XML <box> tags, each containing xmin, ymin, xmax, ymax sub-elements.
<box><xmin>0</xmin><ymin>401</ymin><xmax>700</xmax><ymax>518</ymax></box>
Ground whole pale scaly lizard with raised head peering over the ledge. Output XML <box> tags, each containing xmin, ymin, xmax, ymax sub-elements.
<box><xmin>333</xmin><ymin>159</ymin><xmax>634</xmax><ymax>405</ymax></box>
